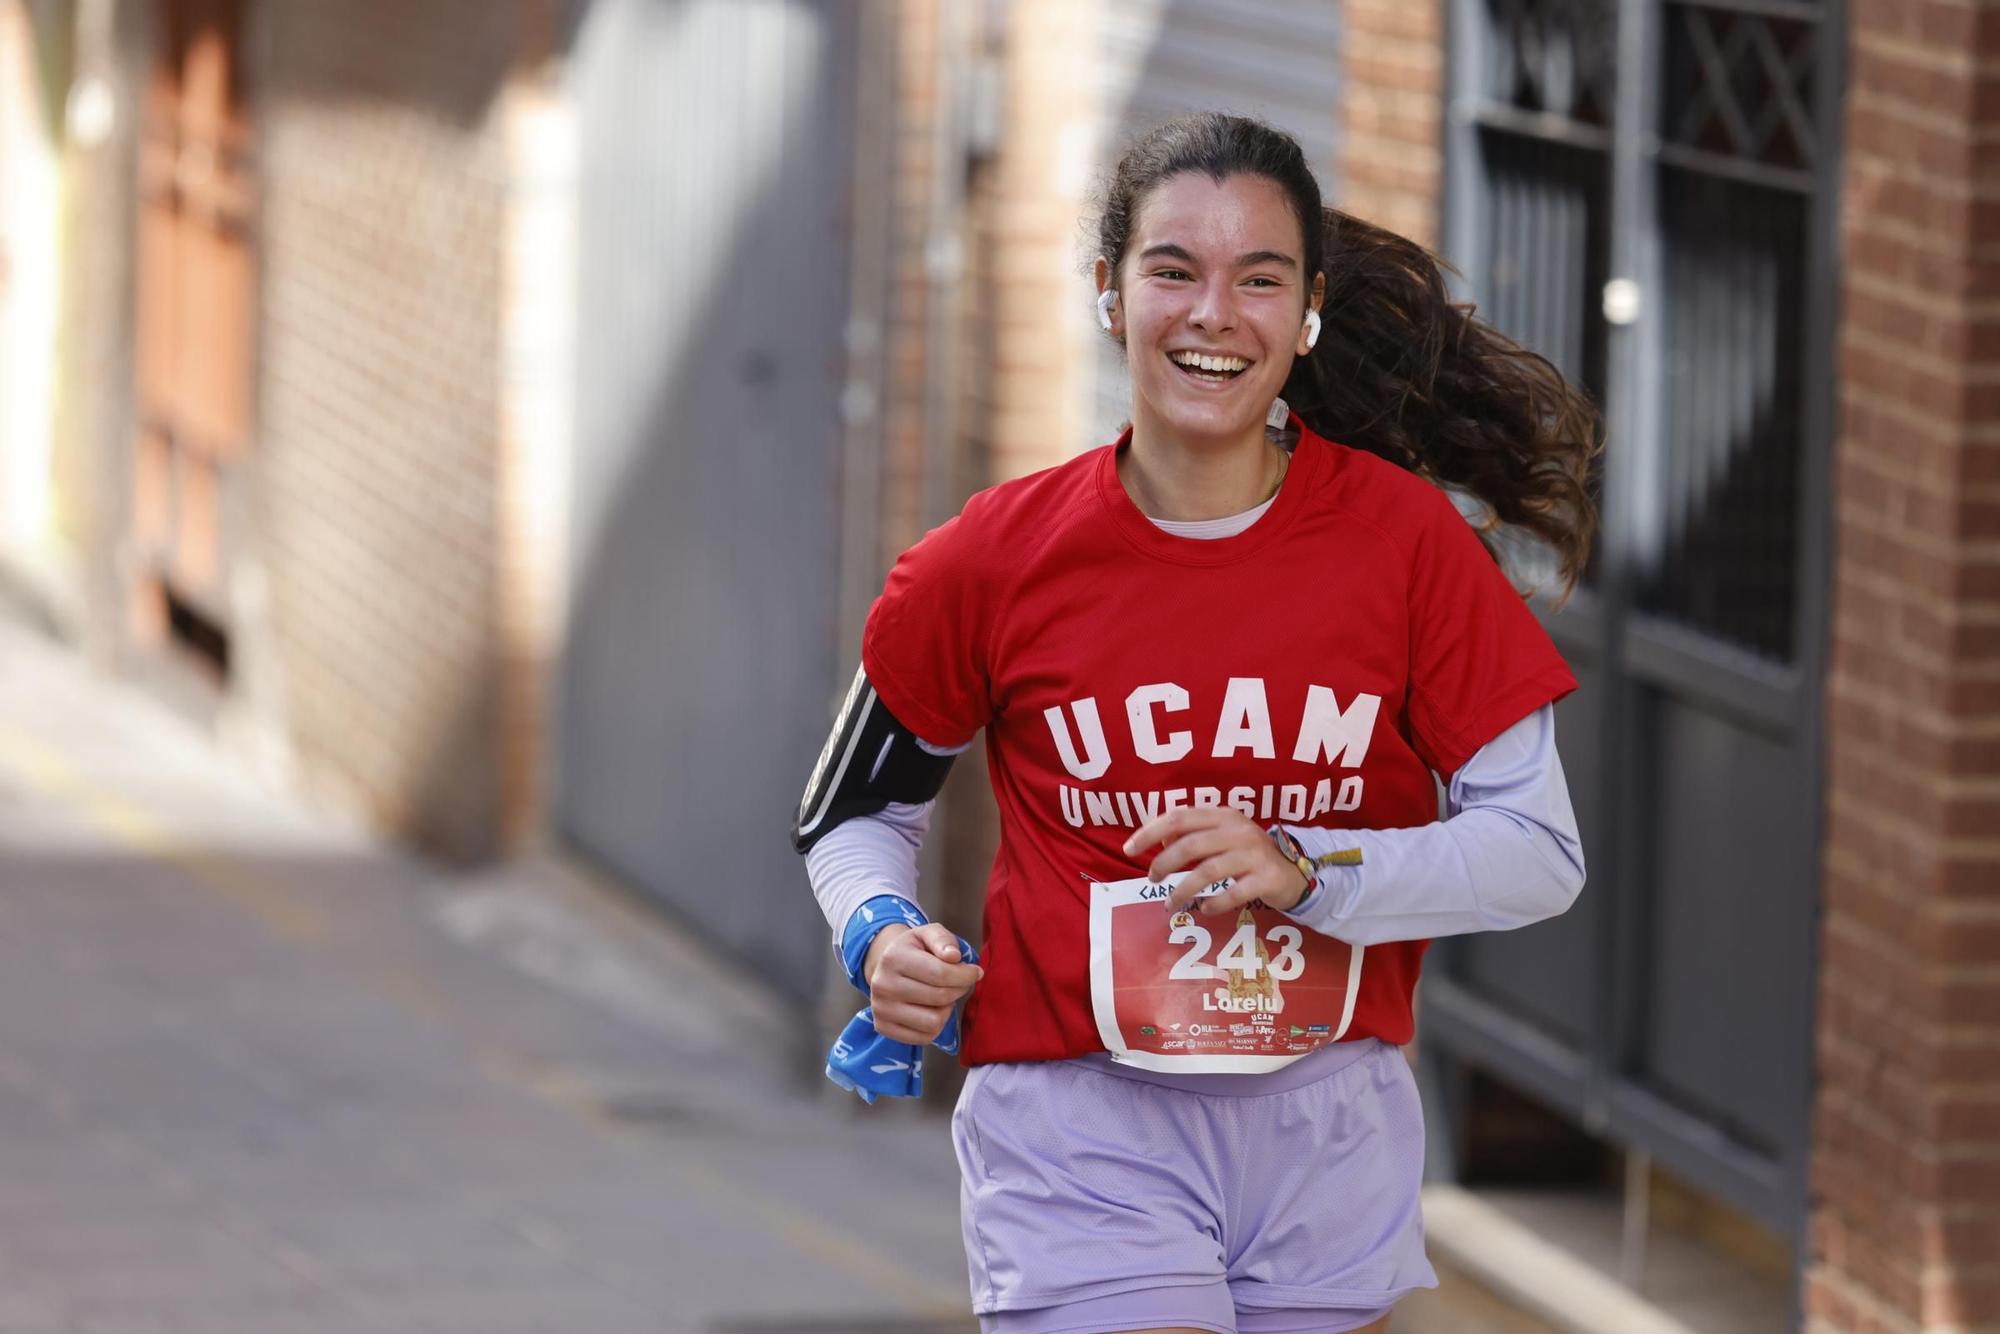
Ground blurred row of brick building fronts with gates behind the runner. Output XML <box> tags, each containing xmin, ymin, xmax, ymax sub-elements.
<box><xmin>0</xmin><ymin>0</ymin><xmax>2000</xmax><ymax>1332</ymax></box>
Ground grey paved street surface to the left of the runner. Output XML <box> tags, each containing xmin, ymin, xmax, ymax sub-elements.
<box><xmin>0</xmin><ymin>624</ymin><xmax>972</xmax><ymax>1334</ymax></box>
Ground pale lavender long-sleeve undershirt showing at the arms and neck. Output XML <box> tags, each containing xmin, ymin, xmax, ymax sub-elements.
<box><xmin>806</xmin><ymin>486</ymin><xmax>1584</xmax><ymax>948</ymax></box>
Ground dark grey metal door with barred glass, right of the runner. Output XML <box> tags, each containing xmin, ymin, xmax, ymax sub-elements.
<box><xmin>1422</xmin><ymin>0</ymin><xmax>1844</xmax><ymax>1242</ymax></box>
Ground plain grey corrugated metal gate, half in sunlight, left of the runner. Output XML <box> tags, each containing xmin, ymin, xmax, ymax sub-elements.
<box><xmin>556</xmin><ymin>0</ymin><xmax>854</xmax><ymax>1000</ymax></box>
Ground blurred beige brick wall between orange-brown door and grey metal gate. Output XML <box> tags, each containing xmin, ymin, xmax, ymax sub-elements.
<box><xmin>246</xmin><ymin>0</ymin><xmax>516</xmax><ymax>856</ymax></box>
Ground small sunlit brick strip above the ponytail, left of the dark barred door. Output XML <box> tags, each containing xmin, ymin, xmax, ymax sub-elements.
<box><xmin>1328</xmin><ymin>0</ymin><xmax>1444</xmax><ymax>246</ymax></box>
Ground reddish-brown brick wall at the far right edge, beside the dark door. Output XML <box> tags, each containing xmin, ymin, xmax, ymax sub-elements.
<box><xmin>1806</xmin><ymin>0</ymin><xmax>2000</xmax><ymax>1332</ymax></box>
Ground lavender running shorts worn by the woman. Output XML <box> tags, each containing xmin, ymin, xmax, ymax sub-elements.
<box><xmin>952</xmin><ymin>1038</ymin><xmax>1438</xmax><ymax>1334</ymax></box>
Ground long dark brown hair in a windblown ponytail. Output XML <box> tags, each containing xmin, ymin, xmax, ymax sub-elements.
<box><xmin>1098</xmin><ymin>112</ymin><xmax>1604</xmax><ymax>598</ymax></box>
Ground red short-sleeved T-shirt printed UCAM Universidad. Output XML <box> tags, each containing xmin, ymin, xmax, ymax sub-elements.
<box><xmin>862</xmin><ymin>430</ymin><xmax>1576</xmax><ymax>1066</ymax></box>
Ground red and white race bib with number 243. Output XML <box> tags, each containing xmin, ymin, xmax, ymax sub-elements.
<box><xmin>1090</xmin><ymin>876</ymin><xmax>1362</xmax><ymax>1074</ymax></box>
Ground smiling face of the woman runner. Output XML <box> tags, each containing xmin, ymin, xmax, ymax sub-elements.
<box><xmin>1098</xmin><ymin>172</ymin><xmax>1318</xmax><ymax>444</ymax></box>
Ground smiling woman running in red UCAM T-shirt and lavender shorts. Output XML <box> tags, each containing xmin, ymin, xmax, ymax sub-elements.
<box><xmin>794</xmin><ymin>114</ymin><xmax>1602</xmax><ymax>1334</ymax></box>
